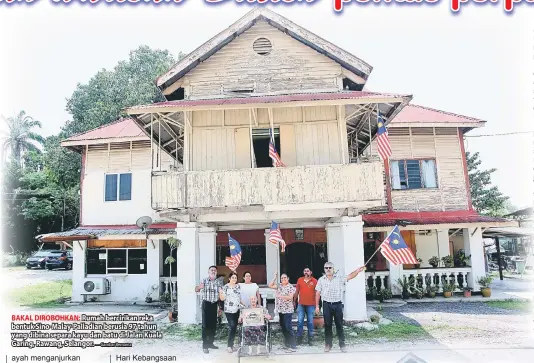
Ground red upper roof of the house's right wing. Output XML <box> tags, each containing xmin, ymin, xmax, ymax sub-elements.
<box><xmin>391</xmin><ymin>105</ymin><xmax>485</xmax><ymax>124</ymax></box>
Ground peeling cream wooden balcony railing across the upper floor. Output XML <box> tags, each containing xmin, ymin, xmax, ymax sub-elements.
<box><xmin>152</xmin><ymin>161</ymin><xmax>386</xmax><ymax>210</ymax></box>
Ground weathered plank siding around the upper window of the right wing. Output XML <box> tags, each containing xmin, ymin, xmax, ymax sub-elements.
<box><xmin>386</xmin><ymin>127</ymin><xmax>468</xmax><ymax>211</ymax></box>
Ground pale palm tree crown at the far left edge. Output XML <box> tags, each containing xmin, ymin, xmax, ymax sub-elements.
<box><xmin>1</xmin><ymin>111</ymin><xmax>44</xmax><ymax>166</ymax></box>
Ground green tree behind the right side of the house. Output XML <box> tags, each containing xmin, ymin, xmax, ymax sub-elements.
<box><xmin>465</xmin><ymin>152</ymin><xmax>510</xmax><ymax>216</ymax></box>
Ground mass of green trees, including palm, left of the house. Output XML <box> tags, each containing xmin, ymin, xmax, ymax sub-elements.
<box><xmin>2</xmin><ymin>46</ymin><xmax>183</xmax><ymax>251</ymax></box>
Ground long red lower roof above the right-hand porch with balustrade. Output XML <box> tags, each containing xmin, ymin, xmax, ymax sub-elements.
<box><xmin>363</xmin><ymin>211</ymin><xmax>514</xmax><ymax>227</ymax></box>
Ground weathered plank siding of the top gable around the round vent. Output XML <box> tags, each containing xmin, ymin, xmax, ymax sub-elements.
<box><xmin>181</xmin><ymin>20</ymin><xmax>342</xmax><ymax>99</ymax></box>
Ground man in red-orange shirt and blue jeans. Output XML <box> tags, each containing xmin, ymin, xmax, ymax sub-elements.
<box><xmin>294</xmin><ymin>267</ymin><xmax>317</xmax><ymax>345</ymax></box>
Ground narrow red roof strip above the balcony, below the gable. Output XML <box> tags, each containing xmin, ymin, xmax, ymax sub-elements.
<box><xmin>129</xmin><ymin>91</ymin><xmax>411</xmax><ymax>111</ymax></box>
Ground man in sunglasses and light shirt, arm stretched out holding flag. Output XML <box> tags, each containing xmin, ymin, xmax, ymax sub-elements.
<box><xmin>315</xmin><ymin>262</ymin><xmax>365</xmax><ymax>353</ymax></box>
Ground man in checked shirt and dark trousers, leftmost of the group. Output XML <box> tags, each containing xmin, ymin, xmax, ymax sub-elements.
<box><xmin>195</xmin><ymin>266</ymin><xmax>223</xmax><ymax>353</ymax></box>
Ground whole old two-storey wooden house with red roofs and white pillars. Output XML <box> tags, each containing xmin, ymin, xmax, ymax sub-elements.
<box><xmin>42</xmin><ymin>8</ymin><xmax>513</xmax><ymax>323</ymax></box>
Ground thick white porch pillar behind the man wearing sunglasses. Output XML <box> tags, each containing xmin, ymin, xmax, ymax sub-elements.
<box><xmin>326</xmin><ymin>216</ymin><xmax>367</xmax><ymax>321</ymax></box>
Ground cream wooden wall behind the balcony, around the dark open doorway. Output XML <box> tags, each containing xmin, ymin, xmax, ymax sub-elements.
<box><xmin>191</xmin><ymin>106</ymin><xmax>347</xmax><ymax>171</ymax></box>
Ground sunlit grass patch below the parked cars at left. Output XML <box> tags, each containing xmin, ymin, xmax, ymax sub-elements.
<box><xmin>8</xmin><ymin>280</ymin><xmax>72</xmax><ymax>307</ymax></box>
